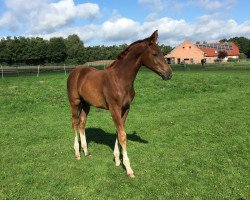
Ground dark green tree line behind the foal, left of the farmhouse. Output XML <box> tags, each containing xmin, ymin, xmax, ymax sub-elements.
<box><xmin>0</xmin><ymin>34</ymin><xmax>173</xmax><ymax>65</ymax></box>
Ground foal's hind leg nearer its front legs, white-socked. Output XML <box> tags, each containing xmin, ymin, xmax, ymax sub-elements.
<box><xmin>79</xmin><ymin>104</ymin><xmax>90</xmax><ymax>156</ymax></box>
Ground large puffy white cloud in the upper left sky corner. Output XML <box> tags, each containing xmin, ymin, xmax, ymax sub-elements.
<box><xmin>0</xmin><ymin>0</ymin><xmax>100</xmax><ymax>33</ymax></box>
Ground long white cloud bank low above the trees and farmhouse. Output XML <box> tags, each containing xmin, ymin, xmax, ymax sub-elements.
<box><xmin>28</xmin><ymin>15</ymin><xmax>250</xmax><ymax>46</ymax></box>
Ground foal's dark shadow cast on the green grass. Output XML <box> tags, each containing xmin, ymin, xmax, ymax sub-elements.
<box><xmin>86</xmin><ymin>128</ymin><xmax>148</xmax><ymax>150</ymax></box>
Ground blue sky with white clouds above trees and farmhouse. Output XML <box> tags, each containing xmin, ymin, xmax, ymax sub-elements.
<box><xmin>0</xmin><ymin>0</ymin><xmax>250</xmax><ymax>46</ymax></box>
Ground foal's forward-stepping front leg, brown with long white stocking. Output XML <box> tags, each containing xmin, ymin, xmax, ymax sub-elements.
<box><xmin>110</xmin><ymin>106</ymin><xmax>135</xmax><ymax>178</ymax></box>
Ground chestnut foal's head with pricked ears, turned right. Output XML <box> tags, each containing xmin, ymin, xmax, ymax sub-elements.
<box><xmin>142</xmin><ymin>31</ymin><xmax>173</xmax><ymax>80</ymax></box>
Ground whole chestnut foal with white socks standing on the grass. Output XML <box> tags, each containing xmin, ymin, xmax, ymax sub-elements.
<box><xmin>67</xmin><ymin>31</ymin><xmax>172</xmax><ymax>177</ymax></box>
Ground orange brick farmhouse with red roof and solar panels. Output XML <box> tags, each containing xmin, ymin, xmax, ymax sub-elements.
<box><xmin>165</xmin><ymin>40</ymin><xmax>240</xmax><ymax>64</ymax></box>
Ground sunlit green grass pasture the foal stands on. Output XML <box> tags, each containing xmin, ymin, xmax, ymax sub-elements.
<box><xmin>0</xmin><ymin>70</ymin><xmax>250</xmax><ymax>200</ymax></box>
